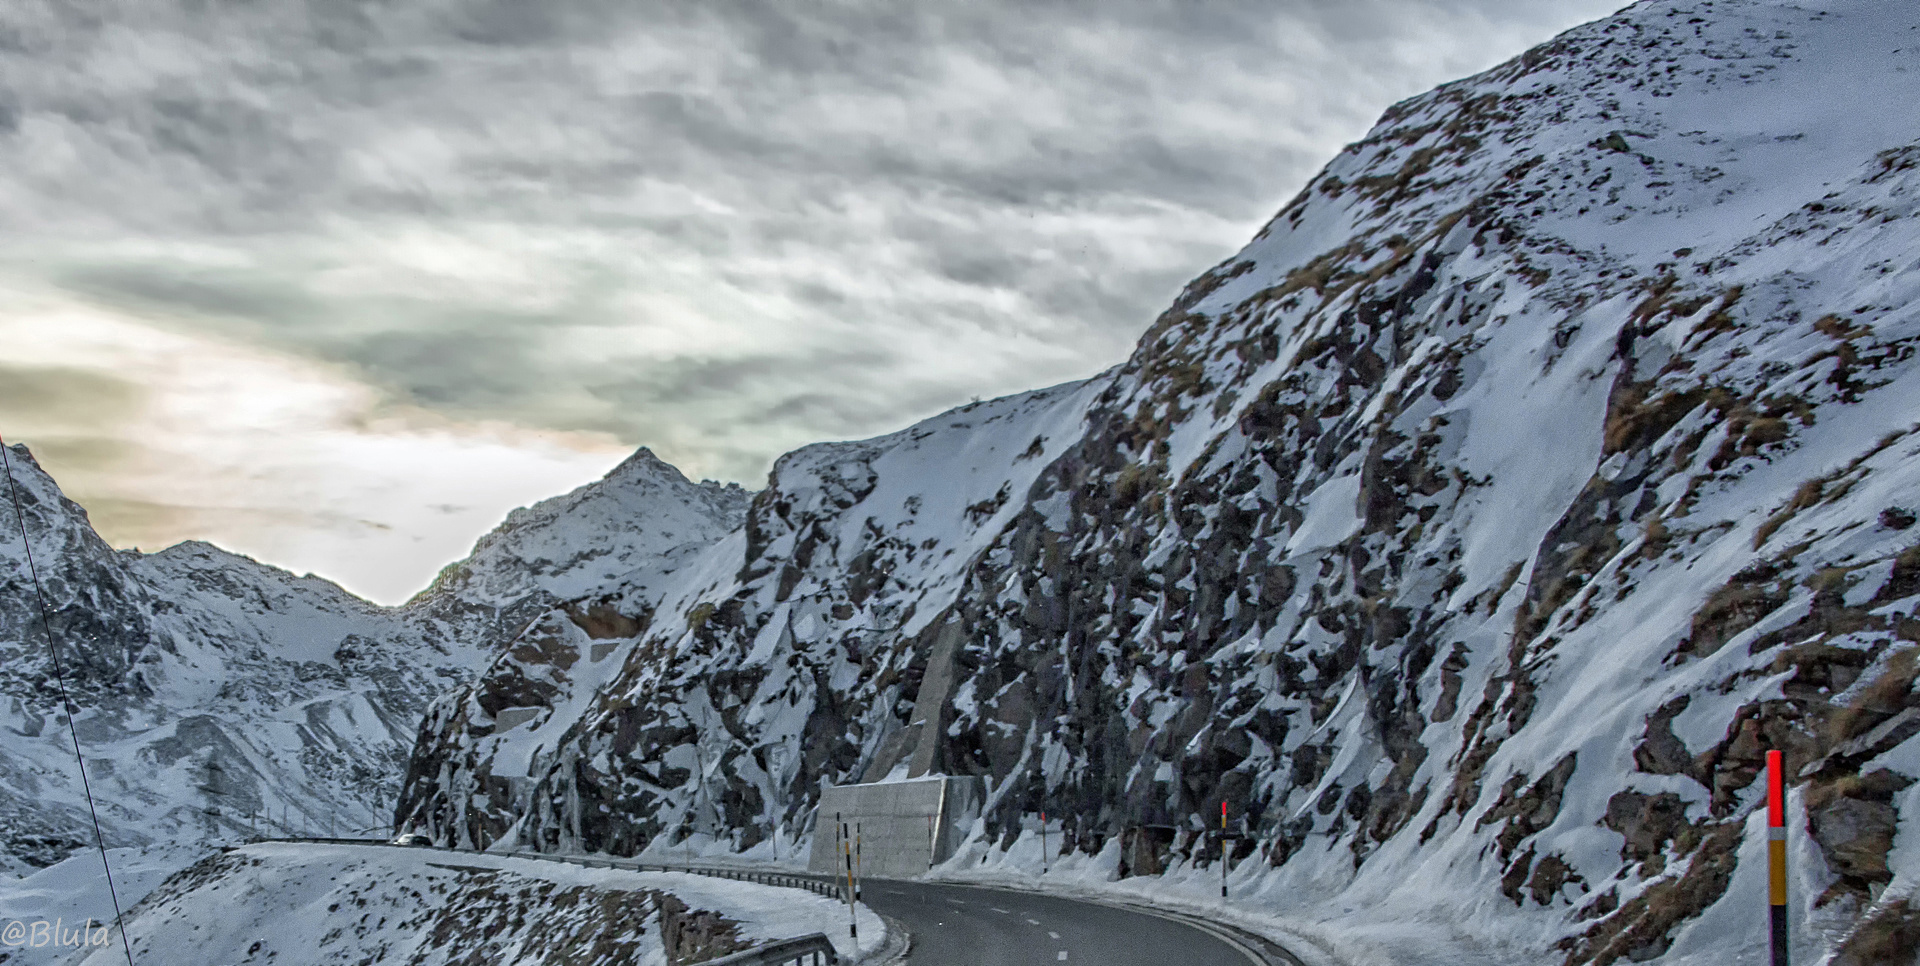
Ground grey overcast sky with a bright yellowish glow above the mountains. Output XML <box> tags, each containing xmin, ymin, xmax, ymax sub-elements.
<box><xmin>0</xmin><ymin>0</ymin><xmax>1620</xmax><ymax>603</ymax></box>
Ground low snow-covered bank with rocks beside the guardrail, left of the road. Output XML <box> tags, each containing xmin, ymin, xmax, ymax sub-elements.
<box><xmin>77</xmin><ymin>843</ymin><xmax>881</xmax><ymax>966</ymax></box>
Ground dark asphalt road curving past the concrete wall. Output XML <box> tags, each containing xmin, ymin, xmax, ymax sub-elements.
<box><xmin>862</xmin><ymin>880</ymin><xmax>1254</xmax><ymax>966</ymax></box>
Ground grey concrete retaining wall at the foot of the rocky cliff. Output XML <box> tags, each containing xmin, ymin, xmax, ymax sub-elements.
<box><xmin>806</xmin><ymin>776</ymin><xmax>985</xmax><ymax>878</ymax></box>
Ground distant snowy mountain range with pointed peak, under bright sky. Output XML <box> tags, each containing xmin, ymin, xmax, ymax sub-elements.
<box><xmin>0</xmin><ymin>446</ymin><xmax>747</xmax><ymax>872</ymax></box>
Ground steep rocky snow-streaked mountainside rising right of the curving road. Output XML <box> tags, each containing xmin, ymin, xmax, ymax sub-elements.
<box><xmin>401</xmin><ymin>0</ymin><xmax>1920</xmax><ymax>964</ymax></box>
